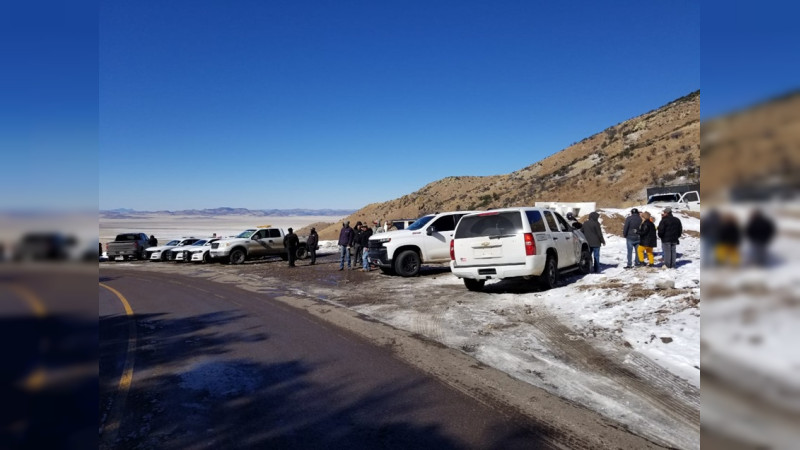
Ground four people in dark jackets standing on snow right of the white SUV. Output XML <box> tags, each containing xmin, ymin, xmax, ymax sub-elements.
<box><xmin>567</xmin><ymin>207</ymin><xmax>683</xmax><ymax>273</ymax></box>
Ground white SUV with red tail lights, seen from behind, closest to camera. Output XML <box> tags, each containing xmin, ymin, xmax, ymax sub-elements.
<box><xmin>450</xmin><ymin>208</ymin><xmax>591</xmax><ymax>291</ymax></box>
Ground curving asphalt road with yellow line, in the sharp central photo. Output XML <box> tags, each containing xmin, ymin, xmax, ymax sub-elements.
<box><xmin>99</xmin><ymin>268</ymin><xmax>656</xmax><ymax>449</ymax></box>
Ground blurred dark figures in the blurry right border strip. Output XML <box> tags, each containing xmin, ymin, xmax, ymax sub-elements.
<box><xmin>700</xmin><ymin>208</ymin><xmax>777</xmax><ymax>267</ymax></box>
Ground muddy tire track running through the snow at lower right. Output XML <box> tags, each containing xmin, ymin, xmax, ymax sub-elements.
<box><xmin>526</xmin><ymin>311</ymin><xmax>700</xmax><ymax>433</ymax></box>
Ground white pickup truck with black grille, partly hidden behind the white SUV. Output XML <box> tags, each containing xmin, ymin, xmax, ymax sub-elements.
<box><xmin>369</xmin><ymin>211</ymin><xmax>475</xmax><ymax>277</ymax></box>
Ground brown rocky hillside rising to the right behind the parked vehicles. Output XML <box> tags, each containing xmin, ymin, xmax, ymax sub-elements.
<box><xmin>300</xmin><ymin>91</ymin><xmax>700</xmax><ymax>239</ymax></box>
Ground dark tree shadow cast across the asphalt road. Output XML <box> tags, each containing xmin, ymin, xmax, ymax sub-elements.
<box><xmin>100</xmin><ymin>312</ymin><xmax>540</xmax><ymax>449</ymax></box>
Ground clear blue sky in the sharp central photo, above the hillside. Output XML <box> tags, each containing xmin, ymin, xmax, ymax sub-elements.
<box><xmin>99</xmin><ymin>0</ymin><xmax>700</xmax><ymax>210</ymax></box>
